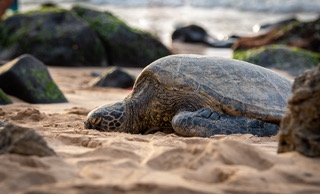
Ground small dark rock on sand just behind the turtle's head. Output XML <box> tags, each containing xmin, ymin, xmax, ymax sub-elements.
<box><xmin>90</xmin><ymin>67</ymin><xmax>134</xmax><ymax>88</ymax></box>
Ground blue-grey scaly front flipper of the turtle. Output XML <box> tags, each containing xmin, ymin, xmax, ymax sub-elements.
<box><xmin>172</xmin><ymin>108</ymin><xmax>279</xmax><ymax>137</ymax></box>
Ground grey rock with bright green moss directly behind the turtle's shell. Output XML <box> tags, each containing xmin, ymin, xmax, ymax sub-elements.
<box><xmin>233</xmin><ymin>45</ymin><xmax>320</xmax><ymax>76</ymax></box>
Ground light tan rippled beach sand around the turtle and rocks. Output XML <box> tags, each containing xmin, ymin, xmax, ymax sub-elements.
<box><xmin>0</xmin><ymin>59</ymin><xmax>320</xmax><ymax>194</ymax></box>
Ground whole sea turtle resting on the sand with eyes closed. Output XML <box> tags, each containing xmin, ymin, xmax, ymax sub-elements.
<box><xmin>84</xmin><ymin>55</ymin><xmax>292</xmax><ymax>137</ymax></box>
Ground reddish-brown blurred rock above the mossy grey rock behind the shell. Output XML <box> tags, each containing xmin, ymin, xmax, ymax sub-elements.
<box><xmin>233</xmin><ymin>18</ymin><xmax>320</xmax><ymax>53</ymax></box>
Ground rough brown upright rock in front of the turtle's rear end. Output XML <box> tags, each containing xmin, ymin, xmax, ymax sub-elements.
<box><xmin>278</xmin><ymin>67</ymin><xmax>320</xmax><ymax>157</ymax></box>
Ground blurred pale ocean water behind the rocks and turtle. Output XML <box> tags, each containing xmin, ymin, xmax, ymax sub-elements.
<box><xmin>19</xmin><ymin>0</ymin><xmax>320</xmax><ymax>57</ymax></box>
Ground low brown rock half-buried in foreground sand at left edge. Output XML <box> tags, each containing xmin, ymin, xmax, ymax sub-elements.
<box><xmin>0</xmin><ymin>123</ymin><xmax>56</xmax><ymax>157</ymax></box>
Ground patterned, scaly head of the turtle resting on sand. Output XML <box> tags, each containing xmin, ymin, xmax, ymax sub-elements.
<box><xmin>84</xmin><ymin>102</ymin><xmax>126</xmax><ymax>131</ymax></box>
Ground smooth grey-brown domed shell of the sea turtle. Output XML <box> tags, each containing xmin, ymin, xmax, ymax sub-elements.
<box><xmin>133</xmin><ymin>55</ymin><xmax>292</xmax><ymax>123</ymax></box>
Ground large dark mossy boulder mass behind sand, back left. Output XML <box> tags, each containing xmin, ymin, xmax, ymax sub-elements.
<box><xmin>0</xmin><ymin>6</ymin><xmax>171</xmax><ymax>67</ymax></box>
